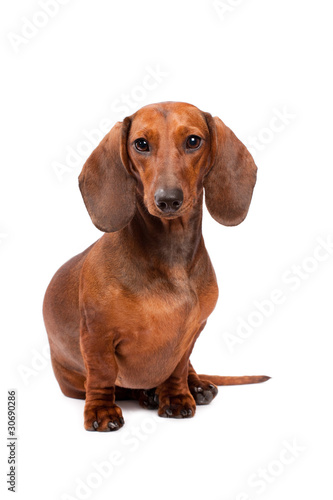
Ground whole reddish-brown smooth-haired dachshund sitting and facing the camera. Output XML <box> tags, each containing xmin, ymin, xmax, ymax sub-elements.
<box><xmin>43</xmin><ymin>102</ymin><xmax>269</xmax><ymax>431</ymax></box>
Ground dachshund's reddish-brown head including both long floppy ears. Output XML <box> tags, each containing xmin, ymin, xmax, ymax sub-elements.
<box><xmin>79</xmin><ymin>102</ymin><xmax>257</xmax><ymax>232</ymax></box>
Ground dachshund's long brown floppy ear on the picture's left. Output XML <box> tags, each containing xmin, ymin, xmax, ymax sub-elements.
<box><xmin>79</xmin><ymin>118</ymin><xmax>136</xmax><ymax>233</ymax></box>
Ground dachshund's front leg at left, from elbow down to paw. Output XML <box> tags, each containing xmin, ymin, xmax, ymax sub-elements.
<box><xmin>81</xmin><ymin>321</ymin><xmax>124</xmax><ymax>432</ymax></box>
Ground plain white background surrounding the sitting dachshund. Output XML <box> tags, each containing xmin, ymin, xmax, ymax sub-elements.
<box><xmin>0</xmin><ymin>0</ymin><xmax>333</xmax><ymax>500</ymax></box>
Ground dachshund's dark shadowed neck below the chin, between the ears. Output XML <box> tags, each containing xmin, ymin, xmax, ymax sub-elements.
<box><xmin>126</xmin><ymin>193</ymin><xmax>203</xmax><ymax>268</ymax></box>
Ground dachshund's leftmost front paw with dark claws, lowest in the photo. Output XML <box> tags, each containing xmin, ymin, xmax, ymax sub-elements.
<box><xmin>84</xmin><ymin>403</ymin><xmax>125</xmax><ymax>432</ymax></box>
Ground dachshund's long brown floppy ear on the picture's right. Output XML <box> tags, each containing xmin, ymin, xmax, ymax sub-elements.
<box><xmin>204</xmin><ymin>113</ymin><xmax>257</xmax><ymax>226</ymax></box>
